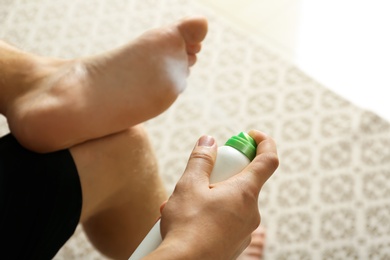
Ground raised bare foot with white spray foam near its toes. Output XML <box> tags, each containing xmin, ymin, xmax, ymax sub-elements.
<box><xmin>5</xmin><ymin>17</ymin><xmax>207</xmax><ymax>152</ymax></box>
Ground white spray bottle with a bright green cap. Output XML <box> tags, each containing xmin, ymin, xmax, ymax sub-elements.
<box><xmin>129</xmin><ymin>132</ymin><xmax>256</xmax><ymax>260</ymax></box>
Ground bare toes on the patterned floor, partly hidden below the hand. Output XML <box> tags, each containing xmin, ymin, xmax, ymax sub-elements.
<box><xmin>237</xmin><ymin>226</ymin><xmax>265</xmax><ymax>260</ymax></box>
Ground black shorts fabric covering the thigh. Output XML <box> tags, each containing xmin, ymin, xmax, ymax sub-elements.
<box><xmin>0</xmin><ymin>134</ymin><xmax>82</xmax><ymax>259</ymax></box>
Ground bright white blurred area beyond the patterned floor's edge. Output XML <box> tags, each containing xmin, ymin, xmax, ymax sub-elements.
<box><xmin>200</xmin><ymin>0</ymin><xmax>390</xmax><ymax>119</ymax></box>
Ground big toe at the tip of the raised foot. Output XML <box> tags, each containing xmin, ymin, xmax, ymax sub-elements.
<box><xmin>178</xmin><ymin>16</ymin><xmax>207</xmax><ymax>45</ymax></box>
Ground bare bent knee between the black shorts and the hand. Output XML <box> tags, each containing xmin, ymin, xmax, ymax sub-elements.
<box><xmin>70</xmin><ymin>126</ymin><xmax>167</xmax><ymax>259</ymax></box>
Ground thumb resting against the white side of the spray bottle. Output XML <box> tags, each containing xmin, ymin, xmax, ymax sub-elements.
<box><xmin>179</xmin><ymin>136</ymin><xmax>217</xmax><ymax>187</ymax></box>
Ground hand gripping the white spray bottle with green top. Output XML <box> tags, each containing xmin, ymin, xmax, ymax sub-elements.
<box><xmin>157</xmin><ymin>130</ymin><xmax>278</xmax><ymax>259</ymax></box>
